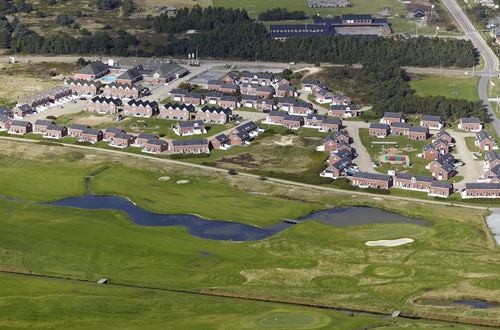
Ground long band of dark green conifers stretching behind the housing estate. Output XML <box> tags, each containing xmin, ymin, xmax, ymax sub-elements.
<box><xmin>0</xmin><ymin>6</ymin><xmax>479</xmax><ymax>67</ymax></box>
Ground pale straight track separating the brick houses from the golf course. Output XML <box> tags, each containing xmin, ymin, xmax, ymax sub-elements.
<box><xmin>0</xmin><ymin>136</ymin><xmax>489</xmax><ymax>210</ymax></box>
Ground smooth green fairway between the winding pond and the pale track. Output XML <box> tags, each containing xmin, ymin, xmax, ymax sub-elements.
<box><xmin>92</xmin><ymin>166</ymin><xmax>320</xmax><ymax>226</ymax></box>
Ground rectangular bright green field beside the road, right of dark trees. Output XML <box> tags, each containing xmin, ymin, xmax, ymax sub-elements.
<box><xmin>410</xmin><ymin>74</ymin><xmax>479</xmax><ymax>101</ymax></box>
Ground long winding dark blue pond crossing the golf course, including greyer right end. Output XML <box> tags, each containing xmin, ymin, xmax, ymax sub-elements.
<box><xmin>48</xmin><ymin>195</ymin><xmax>430</xmax><ymax>241</ymax></box>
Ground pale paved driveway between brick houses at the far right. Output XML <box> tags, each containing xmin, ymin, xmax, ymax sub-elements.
<box><xmin>449</xmin><ymin>132</ymin><xmax>484</xmax><ymax>189</ymax></box>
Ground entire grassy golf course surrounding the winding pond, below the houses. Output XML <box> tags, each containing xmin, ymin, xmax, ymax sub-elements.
<box><xmin>0</xmin><ymin>146</ymin><xmax>500</xmax><ymax>329</ymax></box>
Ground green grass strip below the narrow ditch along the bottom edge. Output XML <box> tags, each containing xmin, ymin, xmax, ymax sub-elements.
<box><xmin>0</xmin><ymin>274</ymin><xmax>478</xmax><ymax>329</ymax></box>
